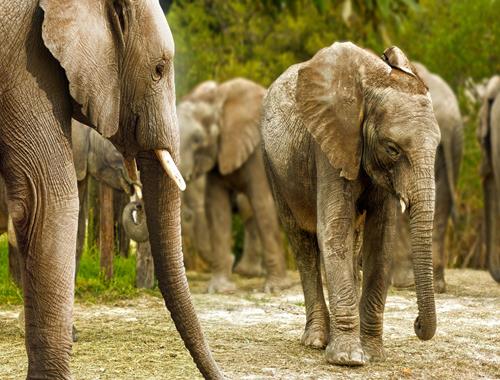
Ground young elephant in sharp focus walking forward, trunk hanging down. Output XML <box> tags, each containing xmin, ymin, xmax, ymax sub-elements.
<box><xmin>262</xmin><ymin>43</ymin><xmax>440</xmax><ymax>365</ymax></box>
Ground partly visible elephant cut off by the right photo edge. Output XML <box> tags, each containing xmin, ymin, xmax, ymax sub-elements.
<box><xmin>477</xmin><ymin>75</ymin><xmax>500</xmax><ymax>283</ymax></box>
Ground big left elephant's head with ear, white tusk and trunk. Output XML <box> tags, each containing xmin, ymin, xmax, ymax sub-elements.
<box><xmin>39</xmin><ymin>0</ymin><xmax>222</xmax><ymax>378</ymax></box>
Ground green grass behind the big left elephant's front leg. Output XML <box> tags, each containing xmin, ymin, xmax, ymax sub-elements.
<box><xmin>0</xmin><ymin>235</ymin><xmax>159</xmax><ymax>305</ymax></box>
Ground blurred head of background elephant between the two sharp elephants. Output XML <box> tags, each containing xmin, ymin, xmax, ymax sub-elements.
<box><xmin>178</xmin><ymin>78</ymin><xmax>266</xmax><ymax>181</ymax></box>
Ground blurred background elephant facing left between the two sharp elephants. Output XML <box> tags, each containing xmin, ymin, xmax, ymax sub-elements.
<box><xmin>178</xmin><ymin>78</ymin><xmax>289</xmax><ymax>292</ymax></box>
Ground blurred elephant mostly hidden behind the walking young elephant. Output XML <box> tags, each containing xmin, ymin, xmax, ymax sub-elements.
<box><xmin>391</xmin><ymin>63</ymin><xmax>463</xmax><ymax>293</ymax></box>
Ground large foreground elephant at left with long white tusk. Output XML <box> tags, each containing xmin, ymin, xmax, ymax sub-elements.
<box><xmin>0</xmin><ymin>0</ymin><xmax>222</xmax><ymax>379</ymax></box>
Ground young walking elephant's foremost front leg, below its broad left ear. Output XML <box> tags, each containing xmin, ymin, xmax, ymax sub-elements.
<box><xmin>317</xmin><ymin>172</ymin><xmax>365</xmax><ymax>365</ymax></box>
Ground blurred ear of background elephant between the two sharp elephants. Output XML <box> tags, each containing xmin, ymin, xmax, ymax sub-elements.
<box><xmin>216</xmin><ymin>78</ymin><xmax>266</xmax><ymax>175</ymax></box>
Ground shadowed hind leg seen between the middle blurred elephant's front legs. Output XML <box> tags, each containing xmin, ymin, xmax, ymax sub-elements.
<box><xmin>234</xmin><ymin>194</ymin><xmax>263</xmax><ymax>277</ymax></box>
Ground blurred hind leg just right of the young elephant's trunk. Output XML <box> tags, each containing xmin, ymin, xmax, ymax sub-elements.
<box><xmin>432</xmin><ymin>149</ymin><xmax>452</xmax><ymax>293</ymax></box>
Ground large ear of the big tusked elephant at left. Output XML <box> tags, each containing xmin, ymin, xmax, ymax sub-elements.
<box><xmin>40</xmin><ymin>0</ymin><xmax>130</xmax><ymax>137</ymax></box>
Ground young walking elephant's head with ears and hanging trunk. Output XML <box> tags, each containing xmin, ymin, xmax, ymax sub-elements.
<box><xmin>296</xmin><ymin>43</ymin><xmax>440</xmax><ymax>340</ymax></box>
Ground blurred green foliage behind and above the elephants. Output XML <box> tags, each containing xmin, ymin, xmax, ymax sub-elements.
<box><xmin>167</xmin><ymin>0</ymin><xmax>500</xmax><ymax>268</ymax></box>
